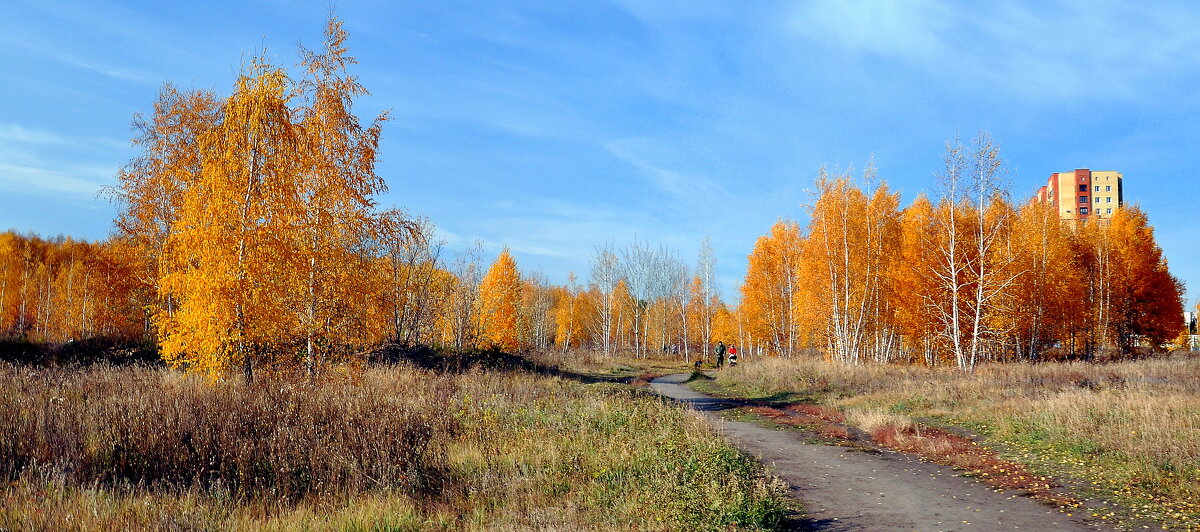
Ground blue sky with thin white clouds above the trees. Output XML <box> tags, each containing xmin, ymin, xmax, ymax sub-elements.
<box><xmin>0</xmin><ymin>0</ymin><xmax>1200</xmax><ymax>307</ymax></box>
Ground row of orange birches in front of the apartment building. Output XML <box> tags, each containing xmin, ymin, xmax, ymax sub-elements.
<box><xmin>740</xmin><ymin>133</ymin><xmax>1183</xmax><ymax>370</ymax></box>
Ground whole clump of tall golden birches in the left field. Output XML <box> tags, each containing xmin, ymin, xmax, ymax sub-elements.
<box><xmin>125</xmin><ymin>19</ymin><xmax>385</xmax><ymax>382</ymax></box>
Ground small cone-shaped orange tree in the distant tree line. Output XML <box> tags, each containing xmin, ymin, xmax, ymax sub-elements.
<box><xmin>478</xmin><ymin>247</ymin><xmax>522</xmax><ymax>351</ymax></box>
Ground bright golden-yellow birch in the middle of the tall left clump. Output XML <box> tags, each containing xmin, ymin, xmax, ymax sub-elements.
<box><xmin>156</xmin><ymin>59</ymin><xmax>301</xmax><ymax>382</ymax></box>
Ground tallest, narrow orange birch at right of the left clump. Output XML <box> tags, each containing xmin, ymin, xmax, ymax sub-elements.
<box><xmin>289</xmin><ymin>19</ymin><xmax>388</xmax><ymax>375</ymax></box>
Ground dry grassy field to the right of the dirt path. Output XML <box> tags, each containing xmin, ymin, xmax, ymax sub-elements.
<box><xmin>701</xmin><ymin>355</ymin><xmax>1200</xmax><ymax>530</ymax></box>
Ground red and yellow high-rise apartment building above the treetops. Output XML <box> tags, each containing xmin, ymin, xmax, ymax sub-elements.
<box><xmin>1037</xmin><ymin>168</ymin><xmax>1124</xmax><ymax>221</ymax></box>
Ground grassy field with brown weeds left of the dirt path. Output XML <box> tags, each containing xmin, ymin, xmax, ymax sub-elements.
<box><xmin>0</xmin><ymin>355</ymin><xmax>786</xmax><ymax>531</ymax></box>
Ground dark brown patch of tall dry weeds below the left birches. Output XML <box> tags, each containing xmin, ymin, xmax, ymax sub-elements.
<box><xmin>0</xmin><ymin>365</ymin><xmax>457</xmax><ymax>500</ymax></box>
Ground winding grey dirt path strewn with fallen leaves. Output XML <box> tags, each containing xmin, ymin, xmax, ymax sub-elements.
<box><xmin>650</xmin><ymin>373</ymin><xmax>1105</xmax><ymax>531</ymax></box>
